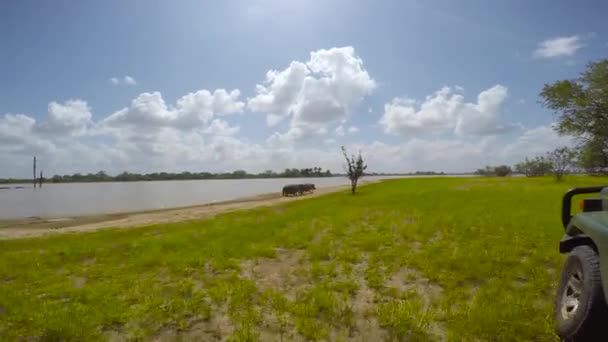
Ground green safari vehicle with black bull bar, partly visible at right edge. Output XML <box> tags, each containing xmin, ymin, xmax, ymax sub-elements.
<box><xmin>554</xmin><ymin>186</ymin><xmax>608</xmax><ymax>341</ymax></box>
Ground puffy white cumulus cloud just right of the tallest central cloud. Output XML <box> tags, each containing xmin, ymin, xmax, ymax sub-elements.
<box><xmin>379</xmin><ymin>84</ymin><xmax>516</xmax><ymax>136</ymax></box>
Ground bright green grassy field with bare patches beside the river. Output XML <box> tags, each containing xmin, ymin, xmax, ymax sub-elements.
<box><xmin>0</xmin><ymin>177</ymin><xmax>608</xmax><ymax>341</ymax></box>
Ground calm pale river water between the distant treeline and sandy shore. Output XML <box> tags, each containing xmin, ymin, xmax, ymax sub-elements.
<box><xmin>0</xmin><ymin>177</ymin><xmax>410</xmax><ymax>219</ymax></box>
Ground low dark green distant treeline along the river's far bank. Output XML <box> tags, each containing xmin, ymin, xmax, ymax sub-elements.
<box><xmin>0</xmin><ymin>167</ymin><xmax>334</xmax><ymax>184</ymax></box>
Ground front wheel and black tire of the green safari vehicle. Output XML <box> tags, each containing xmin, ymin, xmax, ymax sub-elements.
<box><xmin>553</xmin><ymin>246</ymin><xmax>608</xmax><ymax>342</ymax></box>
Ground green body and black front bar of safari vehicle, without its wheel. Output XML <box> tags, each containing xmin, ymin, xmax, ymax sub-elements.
<box><xmin>560</xmin><ymin>185</ymin><xmax>608</xmax><ymax>302</ymax></box>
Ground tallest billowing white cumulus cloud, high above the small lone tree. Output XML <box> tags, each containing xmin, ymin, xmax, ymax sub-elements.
<box><xmin>247</xmin><ymin>47</ymin><xmax>376</xmax><ymax>142</ymax></box>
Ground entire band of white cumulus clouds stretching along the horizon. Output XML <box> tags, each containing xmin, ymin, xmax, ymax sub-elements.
<box><xmin>0</xmin><ymin>47</ymin><xmax>569</xmax><ymax>177</ymax></box>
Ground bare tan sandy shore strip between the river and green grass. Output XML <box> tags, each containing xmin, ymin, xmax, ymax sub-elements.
<box><xmin>0</xmin><ymin>181</ymin><xmax>373</xmax><ymax>240</ymax></box>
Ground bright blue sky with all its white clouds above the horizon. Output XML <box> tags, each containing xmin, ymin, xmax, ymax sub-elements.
<box><xmin>0</xmin><ymin>0</ymin><xmax>608</xmax><ymax>177</ymax></box>
